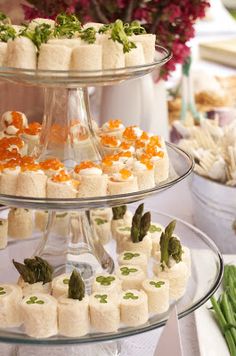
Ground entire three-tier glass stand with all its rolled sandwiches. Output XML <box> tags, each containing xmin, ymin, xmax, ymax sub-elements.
<box><xmin>0</xmin><ymin>14</ymin><xmax>222</xmax><ymax>344</ymax></box>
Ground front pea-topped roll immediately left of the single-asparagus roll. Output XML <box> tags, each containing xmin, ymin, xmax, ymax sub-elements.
<box><xmin>20</xmin><ymin>293</ymin><xmax>58</xmax><ymax>339</ymax></box>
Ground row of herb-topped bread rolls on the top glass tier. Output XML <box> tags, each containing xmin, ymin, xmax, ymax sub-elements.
<box><xmin>0</xmin><ymin>14</ymin><xmax>156</xmax><ymax>71</ymax></box>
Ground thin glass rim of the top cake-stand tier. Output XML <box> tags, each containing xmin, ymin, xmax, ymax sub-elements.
<box><xmin>0</xmin><ymin>43</ymin><xmax>172</xmax><ymax>80</ymax></box>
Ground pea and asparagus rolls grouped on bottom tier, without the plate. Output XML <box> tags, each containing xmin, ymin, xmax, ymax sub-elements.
<box><xmin>0</xmin><ymin>204</ymin><xmax>191</xmax><ymax>339</ymax></box>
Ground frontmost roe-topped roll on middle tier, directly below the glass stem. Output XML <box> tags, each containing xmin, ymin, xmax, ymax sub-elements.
<box><xmin>46</xmin><ymin>170</ymin><xmax>79</xmax><ymax>199</ymax></box>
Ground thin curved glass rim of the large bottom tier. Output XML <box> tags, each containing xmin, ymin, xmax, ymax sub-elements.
<box><xmin>0</xmin><ymin>209</ymin><xmax>224</xmax><ymax>346</ymax></box>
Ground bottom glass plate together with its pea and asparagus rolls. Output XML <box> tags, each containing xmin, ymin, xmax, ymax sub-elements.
<box><xmin>0</xmin><ymin>210</ymin><xmax>223</xmax><ymax>344</ymax></box>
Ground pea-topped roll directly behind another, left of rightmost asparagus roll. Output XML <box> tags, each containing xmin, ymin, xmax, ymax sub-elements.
<box><xmin>118</xmin><ymin>251</ymin><xmax>148</xmax><ymax>274</ymax></box>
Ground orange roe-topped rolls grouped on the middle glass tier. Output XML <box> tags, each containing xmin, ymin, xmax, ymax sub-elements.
<box><xmin>0</xmin><ymin>111</ymin><xmax>169</xmax><ymax>198</ymax></box>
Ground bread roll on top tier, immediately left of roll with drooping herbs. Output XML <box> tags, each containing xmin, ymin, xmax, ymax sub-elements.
<box><xmin>71</xmin><ymin>44</ymin><xmax>102</xmax><ymax>71</ymax></box>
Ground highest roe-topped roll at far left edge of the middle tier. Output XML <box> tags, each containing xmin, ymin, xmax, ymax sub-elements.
<box><xmin>0</xmin><ymin>111</ymin><xmax>28</xmax><ymax>135</ymax></box>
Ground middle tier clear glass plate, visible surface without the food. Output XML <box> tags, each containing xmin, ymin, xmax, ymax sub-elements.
<box><xmin>0</xmin><ymin>143</ymin><xmax>194</xmax><ymax>210</ymax></box>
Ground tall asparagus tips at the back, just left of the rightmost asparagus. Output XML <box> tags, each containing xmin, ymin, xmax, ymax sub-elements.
<box><xmin>131</xmin><ymin>204</ymin><xmax>151</xmax><ymax>243</ymax></box>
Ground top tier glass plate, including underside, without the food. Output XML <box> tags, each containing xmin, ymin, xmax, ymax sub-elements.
<box><xmin>0</xmin><ymin>45</ymin><xmax>172</xmax><ymax>88</ymax></box>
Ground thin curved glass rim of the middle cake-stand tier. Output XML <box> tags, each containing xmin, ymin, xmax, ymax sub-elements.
<box><xmin>0</xmin><ymin>142</ymin><xmax>194</xmax><ymax>210</ymax></box>
